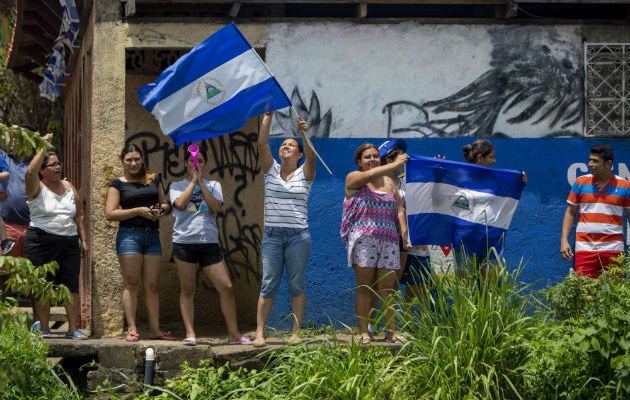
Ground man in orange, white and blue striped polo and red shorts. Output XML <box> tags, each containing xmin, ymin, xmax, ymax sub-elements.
<box><xmin>560</xmin><ymin>144</ymin><xmax>630</xmax><ymax>278</ymax></box>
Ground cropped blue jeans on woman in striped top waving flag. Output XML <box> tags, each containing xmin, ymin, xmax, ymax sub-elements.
<box><xmin>260</xmin><ymin>226</ymin><xmax>311</xmax><ymax>298</ymax></box>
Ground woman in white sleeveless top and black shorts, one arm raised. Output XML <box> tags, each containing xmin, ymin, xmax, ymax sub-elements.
<box><xmin>24</xmin><ymin>133</ymin><xmax>88</xmax><ymax>340</ymax></box>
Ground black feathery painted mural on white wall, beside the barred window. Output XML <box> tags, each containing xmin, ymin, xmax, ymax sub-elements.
<box><xmin>383</xmin><ymin>27</ymin><xmax>584</xmax><ymax>137</ymax></box>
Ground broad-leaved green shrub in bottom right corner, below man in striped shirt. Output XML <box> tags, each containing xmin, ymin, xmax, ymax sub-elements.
<box><xmin>526</xmin><ymin>257</ymin><xmax>630</xmax><ymax>399</ymax></box>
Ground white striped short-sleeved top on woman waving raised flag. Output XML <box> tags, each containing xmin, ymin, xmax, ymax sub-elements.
<box><xmin>265</xmin><ymin>160</ymin><xmax>313</xmax><ymax>228</ymax></box>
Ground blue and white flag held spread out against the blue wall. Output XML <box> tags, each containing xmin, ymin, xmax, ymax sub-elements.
<box><xmin>405</xmin><ymin>155</ymin><xmax>525</xmax><ymax>257</ymax></box>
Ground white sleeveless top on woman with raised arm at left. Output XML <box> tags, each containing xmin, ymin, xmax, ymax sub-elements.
<box><xmin>26</xmin><ymin>182</ymin><xmax>77</xmax><ymax>236</ymax></box>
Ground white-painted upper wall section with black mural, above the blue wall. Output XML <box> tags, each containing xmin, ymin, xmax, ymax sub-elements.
<box><xmin>268</xmin><ymin>23</ymin><xmax>584</xmax><ymax>137</ymax></box>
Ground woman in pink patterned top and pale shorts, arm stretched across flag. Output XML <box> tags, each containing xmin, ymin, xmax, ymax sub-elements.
<box><xmin>340</xmin><ymin>143</ymin><xmax>411</xmax><ymax>344</ymax></box>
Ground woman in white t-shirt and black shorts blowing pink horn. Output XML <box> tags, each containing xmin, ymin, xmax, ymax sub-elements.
<box><xmin>169</xmin><ymin>151</ymin><xmax>252</xmax><ymax>346</ymax></box>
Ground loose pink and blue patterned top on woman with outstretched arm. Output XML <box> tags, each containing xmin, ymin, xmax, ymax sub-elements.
<box><xmin>340</xmin><ymin>185</ymin><xmax>400</xmax><ymax>242</ymax></box>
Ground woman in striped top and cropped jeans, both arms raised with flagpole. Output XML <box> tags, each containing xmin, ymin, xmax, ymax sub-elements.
<box><xmin>254</xmin><ymin>113</ymin><xmax>315</xmax><ymax>347</ymax></box>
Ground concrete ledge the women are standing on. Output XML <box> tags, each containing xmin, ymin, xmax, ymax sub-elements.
<box><xmin>45</xmin><ymin>334</ymin><xmax>401</xmax><ymax>392</ymax></box>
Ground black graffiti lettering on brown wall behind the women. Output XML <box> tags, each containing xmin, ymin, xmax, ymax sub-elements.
<box><xmin>127</xmin><ymin>131</ymin><xmax>262</xmax><ymax>282</ymax></box>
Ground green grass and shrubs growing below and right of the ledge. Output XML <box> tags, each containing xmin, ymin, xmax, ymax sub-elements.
<box><xmin>95</xmin><ymin>252</ymin><xmax>630</xmax><ymax>400</ymax></box>
